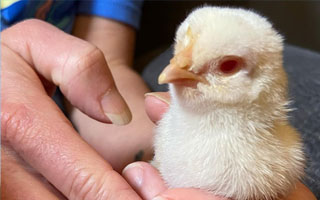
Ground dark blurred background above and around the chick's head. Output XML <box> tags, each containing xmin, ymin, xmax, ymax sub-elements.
<box><xmin>136</xmin><ymin>0</ymin><xmax>320</xmax><ymax>71</ymax></box>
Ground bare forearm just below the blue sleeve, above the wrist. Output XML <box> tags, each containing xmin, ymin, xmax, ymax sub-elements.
<box><xmin>73</xmin><ymin>15</ymin><xmax>136</xmax><ymax>69</ymax></box>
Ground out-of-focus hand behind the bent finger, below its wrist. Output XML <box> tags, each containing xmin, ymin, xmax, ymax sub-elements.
<box><xmin>69</xmin><ymin>66</ymin><xmax>154</xmax><ymax>173</ymax></box>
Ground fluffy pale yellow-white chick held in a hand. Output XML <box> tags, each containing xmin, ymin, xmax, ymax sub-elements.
<box><xmin>153</xmin><ymin>7</ymin><xmax>304</xmax><ymax>200</ymax></box>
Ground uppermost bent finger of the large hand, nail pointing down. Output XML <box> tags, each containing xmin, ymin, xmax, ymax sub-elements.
<box><xmin>2</xmin><ymin>20</ymin><xmax>131</xmax><ymax>125</ymax></box>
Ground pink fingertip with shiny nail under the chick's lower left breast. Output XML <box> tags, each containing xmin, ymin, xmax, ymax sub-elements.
<box><xmin>122</xmin><ymin>162</ymin><xmax>167</xmax><ymax>200</ymax></box>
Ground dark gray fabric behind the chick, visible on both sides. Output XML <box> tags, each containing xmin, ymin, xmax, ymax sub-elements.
<box><xmin>142</xmin><ymin>45</ymin><xmax>320</xmax><ymax>198</ymax></box>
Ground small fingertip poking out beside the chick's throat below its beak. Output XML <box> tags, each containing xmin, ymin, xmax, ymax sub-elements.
<box><xmin>145</xmin><ymin>92</ymin><xmax>170</xmax><ymax>123</ymax></box>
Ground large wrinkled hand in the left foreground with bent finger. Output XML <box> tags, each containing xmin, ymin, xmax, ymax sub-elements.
<box><xmin>1</xmin><ymin>20</ymin><xmax>140</xmax><ymax>200</ymax></box>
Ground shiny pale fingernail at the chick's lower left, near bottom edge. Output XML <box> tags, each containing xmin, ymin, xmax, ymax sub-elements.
<box><xmin>122</xmin><ymin>163</ymin><xmax>143</xmax><ymax>188</ymax></box>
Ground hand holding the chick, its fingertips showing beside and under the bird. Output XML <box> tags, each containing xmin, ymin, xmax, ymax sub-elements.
<box><xmin>123</xmin><ymin>92</ymin><xmax>316</xmax><ymax>200</ymax></box>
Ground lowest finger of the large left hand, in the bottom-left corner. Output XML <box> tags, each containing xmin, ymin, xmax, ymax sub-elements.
<box><xmin>1</xmin><ymin>146</ymin><xmax>65</xmax><ymax>200</ymax></box>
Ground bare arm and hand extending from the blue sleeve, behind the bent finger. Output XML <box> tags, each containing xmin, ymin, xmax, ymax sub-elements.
<box><xmin>69</xmin><ymin>15</ymin><xmax>154</xmax><ymax>172</ymax></box>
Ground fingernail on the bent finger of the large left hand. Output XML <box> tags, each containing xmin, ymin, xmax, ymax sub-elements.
<box><xmin>101</xmin><ymin>88</ymin><xmax>132</xmax><ymax>125</ymax></box>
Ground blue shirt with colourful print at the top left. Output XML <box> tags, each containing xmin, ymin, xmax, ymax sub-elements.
<box><xmin>1</xmin><ymin>0</ymin><xmax>142</xmax><ymax>33</ymax></box>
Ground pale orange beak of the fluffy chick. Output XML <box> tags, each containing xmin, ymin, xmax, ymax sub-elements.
<box><xmin>158</xmin><ymin>54</ymin><xmax>207</xmax><ymax>86</ymax></box>
